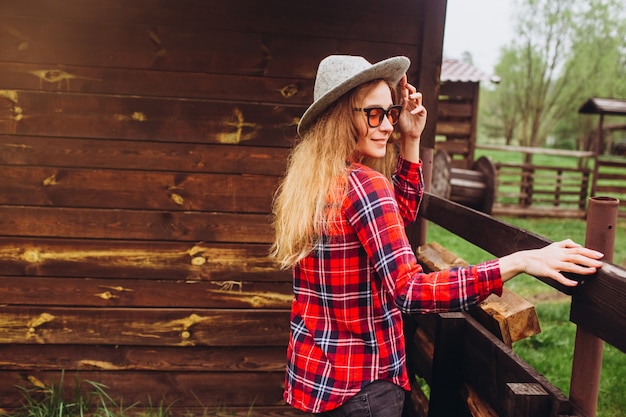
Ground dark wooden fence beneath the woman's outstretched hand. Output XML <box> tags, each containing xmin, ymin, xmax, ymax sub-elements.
<box><xmin>407</xmin><ymin>193</ymin><xmax>626</xmax><ymax>417</ymax></box>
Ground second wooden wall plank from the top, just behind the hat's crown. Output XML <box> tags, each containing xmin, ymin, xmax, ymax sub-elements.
<box><xmin>0</xmin><ymin>14</ymin><xmax>420</xmax><ymax>76</ymax></box>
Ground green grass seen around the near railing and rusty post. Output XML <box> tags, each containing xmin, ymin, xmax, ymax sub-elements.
<box><xmin>427</xmin><ymin>217</ymin><xmax>626</xmax><ymax>417</ymax></box>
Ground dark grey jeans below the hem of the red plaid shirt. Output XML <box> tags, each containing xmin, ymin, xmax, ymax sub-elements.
<box><xmin>313</xmin><ymin>381</ymin><xmax>404</xmax><ymax>417</ymax></box>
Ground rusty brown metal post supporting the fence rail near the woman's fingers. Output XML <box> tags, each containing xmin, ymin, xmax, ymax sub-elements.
<box><xmin>570</xmin><ymin>197</ymin><xmax>619</xmax><ymax>417</ymax></box>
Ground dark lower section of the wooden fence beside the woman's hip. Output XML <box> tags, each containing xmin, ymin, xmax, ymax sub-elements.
<box><xmin>407</xmin><ymin>313</ymin><xmax>584</xmax><ymax>417</ymax></box>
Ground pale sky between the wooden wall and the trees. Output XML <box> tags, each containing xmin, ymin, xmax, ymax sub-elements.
<box><xmin>443</xmin><ymin>0</ymin><xmax>514</xmax><ymax>74</ymax></box>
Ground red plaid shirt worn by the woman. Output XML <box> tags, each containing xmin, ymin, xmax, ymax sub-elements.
<box><xmin>285</xmin><ymin>159</ymin><xmax>502</xmax><ymax>413</ymax></box>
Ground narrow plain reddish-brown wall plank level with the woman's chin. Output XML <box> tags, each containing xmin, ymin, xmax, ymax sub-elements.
<box><xmin>0</xmin><ymin>135</ymin><xmax>289</xmax><ymax>176</ymax></box>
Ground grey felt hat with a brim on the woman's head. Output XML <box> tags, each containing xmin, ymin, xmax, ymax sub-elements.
<box><xmin>298</xmin><ymin>55</ymin><xmax>411</xmax><ymax>134</ymax></box>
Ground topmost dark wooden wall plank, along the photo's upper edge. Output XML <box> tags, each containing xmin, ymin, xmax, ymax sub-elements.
<box><xmin>0</xmin><ymin>0</ymin><xmax>418</xmax><ymax>43</ymax></box>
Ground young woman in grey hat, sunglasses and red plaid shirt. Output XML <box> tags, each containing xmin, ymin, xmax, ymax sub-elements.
<box><xmin>272</xmin><ymin>55</ymin><xmax>603</xmax><ymax>417</ymax></box>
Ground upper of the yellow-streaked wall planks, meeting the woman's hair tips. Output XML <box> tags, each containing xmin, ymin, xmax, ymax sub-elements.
<box><xmin>0</xmin><ymin>237</ymin><xmax>282</xmax><ymax>285</ymax></box>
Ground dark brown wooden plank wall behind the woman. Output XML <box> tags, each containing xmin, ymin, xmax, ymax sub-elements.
<box><xmin>0</xmin><ymin>0</ymin><xmax>445</xmax><ymax>415</ymax></box>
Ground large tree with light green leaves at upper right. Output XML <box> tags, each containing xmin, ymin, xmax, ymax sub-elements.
<box><xmin>485</xmin><ymin>0</ymin><xmax>626</xmax><ymax>146</ymax></box>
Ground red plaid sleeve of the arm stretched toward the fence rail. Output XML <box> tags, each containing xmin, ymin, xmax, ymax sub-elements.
<box><xmin>346</xmin><ymin>162</ymin><xmax>502</xmax><ymax>314</ymax></box>
